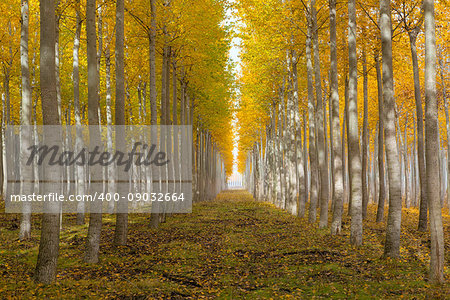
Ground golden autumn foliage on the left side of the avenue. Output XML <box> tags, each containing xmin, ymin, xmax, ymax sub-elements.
<box><xmin>0</xmin><ymin>0</ymin><xmax>233</xmax><ymax>176</ymax></box>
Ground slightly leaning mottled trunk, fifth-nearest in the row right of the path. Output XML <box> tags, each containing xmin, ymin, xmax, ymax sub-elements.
<box><xmin>311</xmin><ymin>0</ymin><xmax>329</xmax><ymax>228</ymax></box>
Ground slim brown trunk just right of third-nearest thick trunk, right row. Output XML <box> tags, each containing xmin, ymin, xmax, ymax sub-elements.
<box><xmin>362</xmin><ymin>49</ymin><xmax>369</xmax><ymax>219</ymax></box>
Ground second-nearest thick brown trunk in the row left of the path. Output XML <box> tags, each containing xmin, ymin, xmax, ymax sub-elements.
<box><xmin>84</xmin><ymin>0</ymin><xmax>102</xmax><ymax>263</ymax></box>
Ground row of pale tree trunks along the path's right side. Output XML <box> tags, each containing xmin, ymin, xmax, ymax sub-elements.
<box><xmin>239</xmin><ymin>0</ymin><xmax>450</xmax><ymax>282</ymax></box>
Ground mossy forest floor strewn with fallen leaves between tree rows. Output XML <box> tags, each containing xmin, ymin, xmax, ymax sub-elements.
<box><xmin>0</xmin><ymin>191</ymin><xmax>450</xmax><ymax>299</ymax></box>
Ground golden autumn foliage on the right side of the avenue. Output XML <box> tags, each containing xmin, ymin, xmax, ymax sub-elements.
<box><xmin>236</xmin><ymin>0</ymin><xmax>450</xmax><ymax>169</ymax></box>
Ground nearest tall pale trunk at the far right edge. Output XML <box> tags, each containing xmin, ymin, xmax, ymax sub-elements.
<box><xmin>423</xmin><ymin>0</ymin><xmax>444</xmax><ymax>283</ymax></box>
